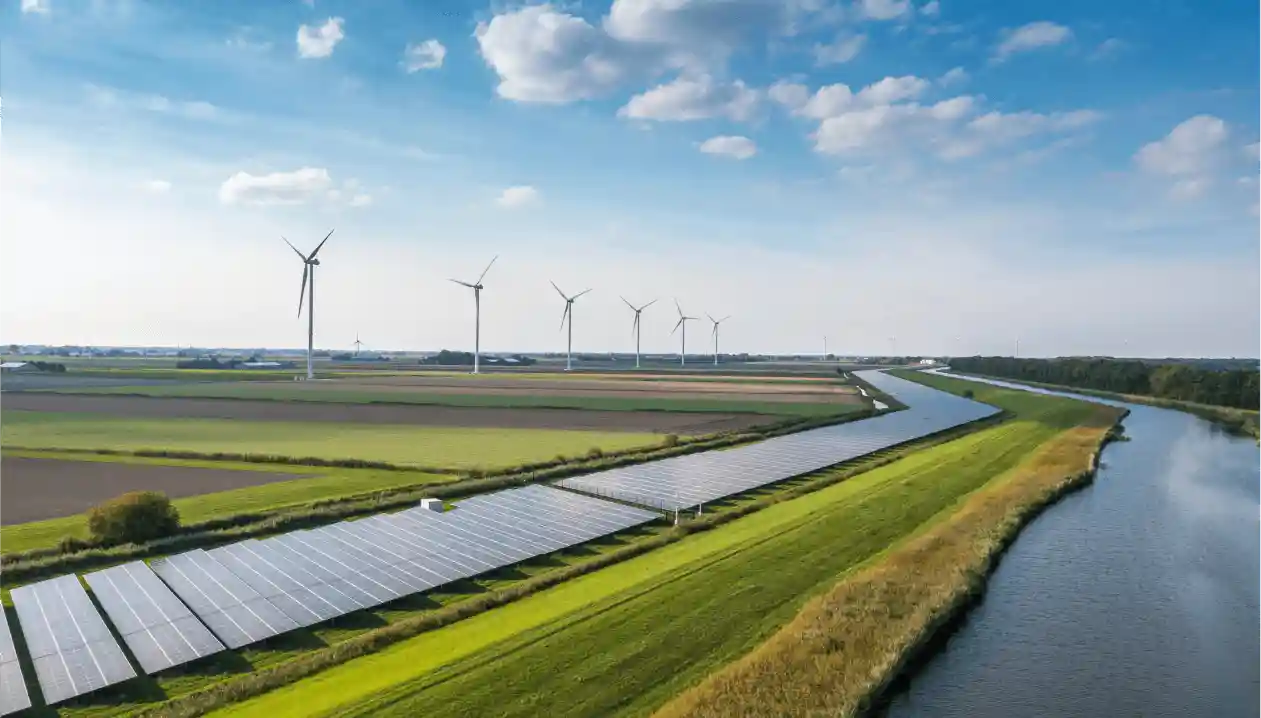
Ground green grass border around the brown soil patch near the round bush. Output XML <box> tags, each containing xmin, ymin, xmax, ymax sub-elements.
<box><xmin>0</xmin><ymin>450</ymin><xmax>459</xmax><ymax>554</ymax></box>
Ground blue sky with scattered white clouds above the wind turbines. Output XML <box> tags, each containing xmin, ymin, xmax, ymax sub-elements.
<box><xmin>0</xmin><ymin>0</ymin><xmax>1261</xmax><ymax>356</ymax></box>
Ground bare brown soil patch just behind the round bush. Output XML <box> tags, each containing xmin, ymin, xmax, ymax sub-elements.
<box><xmin>0</xmin><ymin>457</ymin><xmax>310</xmax><ymax>525</ymax></box>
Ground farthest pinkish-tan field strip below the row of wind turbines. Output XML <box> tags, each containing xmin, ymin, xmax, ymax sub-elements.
<box><xmin>325</xmin><ymin>375</ymin><xmax>860</xmax><ymax>404</ymax></box>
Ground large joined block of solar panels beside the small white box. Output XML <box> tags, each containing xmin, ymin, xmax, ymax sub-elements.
<box><xmin>151</xmin><ymin>486</ymin><xmax>660</xmax><ymax>647</ymax></box>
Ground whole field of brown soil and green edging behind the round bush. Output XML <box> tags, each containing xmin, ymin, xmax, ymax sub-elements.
<box><xmin>0</xmin><ymin>450</ymin><xmax>459</xmax><ymax>554</ymax></box>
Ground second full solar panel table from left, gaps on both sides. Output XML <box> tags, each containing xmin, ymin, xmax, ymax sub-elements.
<box><xmin>83</xmin><ymin>562</ymin><xmax>223</xmax><ymax>675</ymax></box>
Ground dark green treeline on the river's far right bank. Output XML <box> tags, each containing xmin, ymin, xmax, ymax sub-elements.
<box><xmin>950</xmin><ymin>357</ymin><xmax>1261</xmax><ymax>410</ymax></box>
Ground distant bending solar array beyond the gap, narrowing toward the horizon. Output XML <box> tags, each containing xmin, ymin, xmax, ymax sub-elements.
<box><xmin>556</xmin><ymin>371</ymin><xmax>999</xmax><ymax>511</ymax></box>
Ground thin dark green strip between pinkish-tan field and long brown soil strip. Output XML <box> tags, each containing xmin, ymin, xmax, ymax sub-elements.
<box><xmin>48</xmin><ymin>380</ymin><xmax>863</xmax><ymax>416</ymax></box>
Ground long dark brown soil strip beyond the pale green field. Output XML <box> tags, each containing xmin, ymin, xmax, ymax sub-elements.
<box><xmin>4</xmin><ymin>394</ymin><xmax>776</xmax><ymax>434</ymax></box>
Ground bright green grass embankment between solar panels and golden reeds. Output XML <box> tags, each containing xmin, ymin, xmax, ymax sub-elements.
<box><xmin>216</xmin><ymin>381</ymin><xmax>1093</xmax><ymax>718</ymax></box>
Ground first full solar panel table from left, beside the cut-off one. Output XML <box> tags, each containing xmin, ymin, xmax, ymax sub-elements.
<box><xmin>11</xmin><ymin>575</ymin><xmax>136</xmax><ymax>705</ymax></box>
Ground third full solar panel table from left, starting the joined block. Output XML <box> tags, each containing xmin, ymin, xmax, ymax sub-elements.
<box><xmin>149</xmin><ymin>549</ymin><xmax>298</xmax><ymax>649</ymax></box>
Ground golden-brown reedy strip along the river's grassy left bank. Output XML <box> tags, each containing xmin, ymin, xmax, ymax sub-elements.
<box><xmin>654</xmin><ymin>377</ymin><xmax>1125</xmax><ymax>718</ymax></box>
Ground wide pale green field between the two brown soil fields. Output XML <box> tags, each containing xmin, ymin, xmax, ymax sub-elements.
<box><xmin>4</xmin><ymin>411</ymin><xmax>661</xmax><ymax>469</ymax></box>
